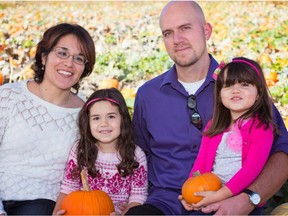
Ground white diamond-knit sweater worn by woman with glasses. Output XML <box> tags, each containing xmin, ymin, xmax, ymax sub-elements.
<box><xmin>0</xmin><ymin>81</ymin><xmax>80</xmax><ymax>201</ymax></box>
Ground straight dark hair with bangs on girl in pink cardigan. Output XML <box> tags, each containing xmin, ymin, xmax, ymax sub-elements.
<box><xmin>204</xmin><ymin>57</ymin><xmax>276</xmax><ymax>136</ymax></box>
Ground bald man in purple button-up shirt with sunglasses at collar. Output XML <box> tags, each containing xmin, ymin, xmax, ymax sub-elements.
<box><xmin>127</xmin><ymin>1</ymin><xmax>288</xmax><ymax>215</ymax></box>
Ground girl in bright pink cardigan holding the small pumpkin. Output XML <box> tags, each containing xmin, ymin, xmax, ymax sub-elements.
<box><xmin>179</xmin><ymin>57</ymin><xmax>277</xmax><ymax>213</ymax></box>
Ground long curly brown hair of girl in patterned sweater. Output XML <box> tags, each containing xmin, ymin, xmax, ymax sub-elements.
<box><xmin>73</xmin><ymin>88</ymin><xmax>139</xmax><ymax>177</ymax></box>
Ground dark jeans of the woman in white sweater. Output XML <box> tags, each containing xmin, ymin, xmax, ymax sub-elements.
<box><xmin>3</xmin><ymin>199</ymin><xmax>55</xmax><ymax>215</ymax></box>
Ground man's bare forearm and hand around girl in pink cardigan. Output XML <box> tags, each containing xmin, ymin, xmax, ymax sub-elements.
<box><xmin>202</xmin><ymin>152</ymin><xmax>288</xmax><ymax>215</ymax></box>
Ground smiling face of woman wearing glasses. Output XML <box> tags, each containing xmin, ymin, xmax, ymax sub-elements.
<box><xmin>42</xmin><ymin>34</ymin><xmax>85</xmax><ymax>90</ymax></box>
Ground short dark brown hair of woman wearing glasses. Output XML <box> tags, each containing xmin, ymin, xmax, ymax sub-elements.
<box><xmin>33</xmin><ymin>23</ymin><xmax>96</xmax><ymax>93</ymax></box>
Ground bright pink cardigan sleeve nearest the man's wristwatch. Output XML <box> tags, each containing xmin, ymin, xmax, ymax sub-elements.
<box><xmin>226</xmin><ymin>125</ymin><xmax>273</xmax><ymax>195</ymax></box>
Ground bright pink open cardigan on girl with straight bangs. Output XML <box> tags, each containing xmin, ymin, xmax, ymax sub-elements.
<box><xmin>189</xmin><ymin>118</ymin><xmax>273</xmax><ymax>195</ymax></box>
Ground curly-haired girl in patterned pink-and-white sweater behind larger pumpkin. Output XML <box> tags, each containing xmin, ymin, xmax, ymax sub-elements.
<box><xmin>54</xmin><ymin>88</ymin><xmax>148</xmax><ymax>214</ymax></box>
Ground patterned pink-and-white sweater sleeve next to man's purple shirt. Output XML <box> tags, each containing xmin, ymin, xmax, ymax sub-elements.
<box><xmin>129</xmin><ymin>146</ymin><xmax>148</xmax><ymax>204</ymax></box>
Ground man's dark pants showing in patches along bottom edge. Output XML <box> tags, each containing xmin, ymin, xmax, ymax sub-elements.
<box><xmin>125</xmin><ymin>204</ymin><xmax>264</xmax><ymax>215</ymax></box>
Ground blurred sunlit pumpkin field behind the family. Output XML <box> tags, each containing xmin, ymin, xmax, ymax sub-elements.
<box><xmin>0</xmin><ymin>1</ymin><xmax>288</xmax><ymax>211</ymax></box>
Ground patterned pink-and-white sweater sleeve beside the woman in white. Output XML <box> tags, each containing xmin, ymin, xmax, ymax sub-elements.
<box><xmin>60</xmin><ymin>142</ymin><xmax>81</xmax><ymax>194</ymax></box>
